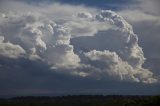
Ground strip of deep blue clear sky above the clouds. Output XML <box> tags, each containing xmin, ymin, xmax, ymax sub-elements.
<box><xmin>0</xmin><ymin>0</ymin><xmax>137</xmax><ymax>10</ymax></box>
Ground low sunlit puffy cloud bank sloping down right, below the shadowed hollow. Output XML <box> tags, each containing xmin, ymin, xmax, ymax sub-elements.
<box><xmin>85</xmin><ymin>50</ymin><xmax>157</xmax><ymax>83</ymax></box>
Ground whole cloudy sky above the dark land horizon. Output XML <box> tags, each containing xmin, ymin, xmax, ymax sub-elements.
<box><xmin>0</xmin><ymin>0</ymin><xmax>160</xmax><ymax>97</ymax></box>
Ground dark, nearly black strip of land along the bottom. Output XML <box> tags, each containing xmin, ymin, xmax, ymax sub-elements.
<box><xmin>0</xmin><ymin>95</ymin><xmax>160</xmax><ymax>106</ymax></box>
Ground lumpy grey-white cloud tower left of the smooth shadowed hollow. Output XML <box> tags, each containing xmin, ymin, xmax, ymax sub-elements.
<box><xmin>0</xmin><ymin>11</ymin><xmax>79</xmax><ymax>67</ymax></box>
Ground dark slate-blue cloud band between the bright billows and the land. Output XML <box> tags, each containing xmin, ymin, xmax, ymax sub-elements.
<box><xmin>0</xmin><ymin>58</ymin><xmax>160</xmax><ymax>97</ymax></box>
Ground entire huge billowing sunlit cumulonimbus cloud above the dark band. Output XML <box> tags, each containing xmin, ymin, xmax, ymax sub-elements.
<box><xmin>0</xmin><ymin>1</ymin><xmax>157</xmax><ymax>83</ymax></box>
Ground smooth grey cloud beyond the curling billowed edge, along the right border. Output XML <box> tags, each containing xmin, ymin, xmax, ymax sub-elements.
<box><xmin>118</xmin><ymin>0</ymin><xmax>160</xmax><ymax>82</ymax></box>
